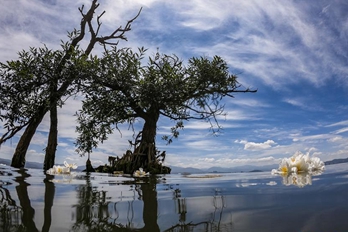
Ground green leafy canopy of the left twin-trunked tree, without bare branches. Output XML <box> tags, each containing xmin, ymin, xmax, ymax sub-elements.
<box><xmin>0</xmin><ymin>44</ymin><xmax>82</xmax><ymax>144</ymax></box>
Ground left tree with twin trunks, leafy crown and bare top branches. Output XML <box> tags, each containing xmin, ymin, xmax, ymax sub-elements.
<box><xmin>0</xmin><ymin>0</ymin><xmax>141</xmax><ymax>170</ymax></box>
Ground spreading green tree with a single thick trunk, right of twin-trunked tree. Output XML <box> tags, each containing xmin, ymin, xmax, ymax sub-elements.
<box><xmin>76</xmin><ymin>47</ymin><xmax>256</xmax><ymax>173</ymax></box>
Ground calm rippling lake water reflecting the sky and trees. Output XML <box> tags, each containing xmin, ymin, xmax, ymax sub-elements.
<box><xmin>0</xmin><ymin>164</ymin><xmax>348</xmax><ymax>232</ymax></box>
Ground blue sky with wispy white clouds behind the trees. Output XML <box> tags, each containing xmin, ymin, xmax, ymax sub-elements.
<box><xmin>0</xmin><ymin>0</ymin><xmax>348</xmax><ymax>168</ymax></box>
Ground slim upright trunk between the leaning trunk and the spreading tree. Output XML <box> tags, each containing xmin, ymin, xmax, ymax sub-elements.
<box><xmin>43</xmin><ymin>96</ymin><xmax>58</xmax><ymax>171</ymax></box>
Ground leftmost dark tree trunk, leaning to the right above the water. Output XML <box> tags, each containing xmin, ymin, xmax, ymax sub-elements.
<box><xmin>11</xmin><ymin>107</ymin><xmax>47</xmax><ymax>168</ymax></box>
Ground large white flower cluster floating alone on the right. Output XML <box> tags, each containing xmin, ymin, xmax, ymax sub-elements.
<box><xmin>272</xmin><ymin>151</ymin><xmax>325</xmax><ymax>187</ymax></box>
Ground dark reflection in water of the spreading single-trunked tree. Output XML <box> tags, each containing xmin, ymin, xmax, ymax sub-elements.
<box><xmin>72</xmin><ymin>175</ymin><xmax>232</xmax><ymax>232</ymax></box>
